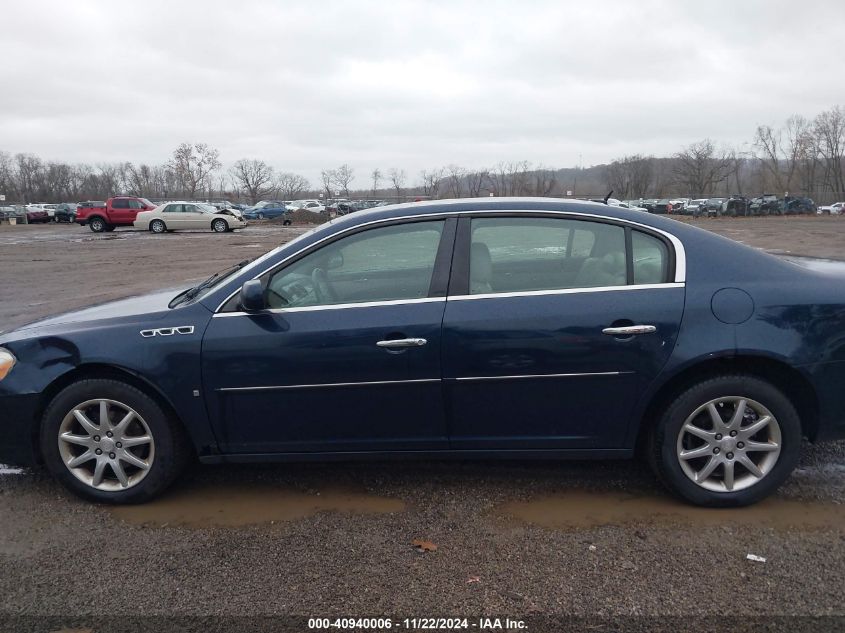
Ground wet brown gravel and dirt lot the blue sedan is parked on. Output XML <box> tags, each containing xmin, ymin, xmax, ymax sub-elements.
<box><xmin>0</xmin><ymin>217</ymin><xmax>845</xmax><ymax>631</ymax></box>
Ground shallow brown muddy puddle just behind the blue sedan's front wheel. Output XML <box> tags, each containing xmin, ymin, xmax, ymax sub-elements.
<box><xmin>110</xmin><ymin>485</ymin><xmax>405</xmax><ymax>528</ymax></box>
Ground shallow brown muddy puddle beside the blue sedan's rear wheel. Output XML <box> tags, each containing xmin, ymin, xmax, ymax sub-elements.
<box><xmin>496</xmin><ymin>491</ymin><xmax>845</xmax><ymax>530</ymax></box>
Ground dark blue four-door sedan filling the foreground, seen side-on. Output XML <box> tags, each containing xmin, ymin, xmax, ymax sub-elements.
<box><xmin>0</xmin><ymin>198</ymin><xmax>845</xmax><ymax>506</ymax></box>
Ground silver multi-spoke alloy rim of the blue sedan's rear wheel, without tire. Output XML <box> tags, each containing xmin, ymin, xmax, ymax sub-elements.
<box><xmin>676</xmin><ymin>396</ymin><xmax>782</xmax><ymax>492</ymax></box>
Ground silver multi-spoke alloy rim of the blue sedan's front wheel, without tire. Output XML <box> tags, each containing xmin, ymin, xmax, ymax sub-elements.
<box><xmin>57</xmin><ymin>398</ymin><xmax>155</xmax><ymax>492</ymax></box>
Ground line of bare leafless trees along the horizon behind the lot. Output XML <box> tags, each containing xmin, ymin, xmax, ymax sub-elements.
<box><xmin>0</xmin><ymin>106</ymin><xmax>845</xmax><ymax>204</ymax></box>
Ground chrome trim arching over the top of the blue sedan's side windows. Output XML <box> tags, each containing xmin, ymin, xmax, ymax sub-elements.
<box><xmin>211</xmin><ymin>209</ymin><xmax>687</xmax><ymax>316</ymax></box>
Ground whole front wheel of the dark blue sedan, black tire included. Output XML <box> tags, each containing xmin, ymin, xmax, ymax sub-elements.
<box><xmin>40</xmin><ymin>379</ymin><xmax>191</xmax><ymax>504</ymax></box>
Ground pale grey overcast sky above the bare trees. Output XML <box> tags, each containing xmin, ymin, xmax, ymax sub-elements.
<box><xmin>0</xmin><ymin>0</ymin><xmax>845</xmax><ymax>186</ymax></box>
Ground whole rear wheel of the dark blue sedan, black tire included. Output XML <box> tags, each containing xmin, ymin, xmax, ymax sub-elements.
<box><xmin>649</xmin><ymin>374</ymin><xmax>802</xmax><ymax>507</ymax></box>
